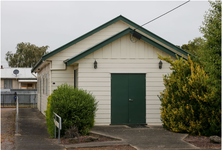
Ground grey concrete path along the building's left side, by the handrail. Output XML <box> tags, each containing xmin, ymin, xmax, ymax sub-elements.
<box><xmin>15</xmin><ymin>108</ymin><xmax>65</xmax><ymax>150</ymax></box>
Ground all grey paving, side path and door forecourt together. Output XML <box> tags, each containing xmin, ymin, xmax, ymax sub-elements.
<box><xmin>15</xmin><ymin>108</ymin><xmax>220</xmax><ymax>150</ymax></box>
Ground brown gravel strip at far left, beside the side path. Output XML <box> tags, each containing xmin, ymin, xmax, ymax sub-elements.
<box><xmin>1</xmin><ymin>108</ymin><xmax>15</xmax><ymax>150</ymax></box>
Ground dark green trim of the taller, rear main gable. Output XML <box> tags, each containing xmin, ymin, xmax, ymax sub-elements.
<box><xmin>31</xmin><ymin>15</ymin><xmax>188</xmax><ymax>72</ymax></box>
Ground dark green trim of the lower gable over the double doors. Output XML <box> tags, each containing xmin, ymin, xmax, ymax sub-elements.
<box><xmin>66</xmin><ymin>28</ymin><xmax>188</xmax><ymax>66</ymax></box>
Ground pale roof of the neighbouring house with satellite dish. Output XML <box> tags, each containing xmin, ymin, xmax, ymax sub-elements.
<box><xmin>0</xmin><ymin>68</ymin><xmax>36</xmax><ymax>79</ymax></box>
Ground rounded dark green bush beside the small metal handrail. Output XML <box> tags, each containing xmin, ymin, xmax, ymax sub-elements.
<box><xmin>47</xmin><ymin>84</ymin><xmax>97</xmax><ymax>136</ymax></box>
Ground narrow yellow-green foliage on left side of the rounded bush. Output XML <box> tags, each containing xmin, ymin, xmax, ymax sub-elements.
<box><xmin>45</xmin><ymin>95</ymin><xmax>55</xmax><ymax>138</ymax></box>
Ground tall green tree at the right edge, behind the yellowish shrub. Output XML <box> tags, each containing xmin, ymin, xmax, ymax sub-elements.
<box><xmin>199</xmin><ymin>1</ymin><xmax>221</xmax><ymax>99</ymax></box>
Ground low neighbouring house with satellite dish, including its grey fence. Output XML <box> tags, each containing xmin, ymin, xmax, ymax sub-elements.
<box><xmin>0</xmin><ymin>66</ymin><xmax>37</xmax><ymax>107</ymax></box>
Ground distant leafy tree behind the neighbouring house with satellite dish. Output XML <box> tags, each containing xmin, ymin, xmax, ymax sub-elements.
<box><xmin>5</xmin><ymin>42</ymin><xmax>49</xmax><ymax>67</ymax></box>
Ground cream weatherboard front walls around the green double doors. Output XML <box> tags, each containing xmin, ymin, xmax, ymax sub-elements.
<box><xmin>38</xmin><ymin>21</ymin><xmax>177</xmax><ymax>125</ymax></box>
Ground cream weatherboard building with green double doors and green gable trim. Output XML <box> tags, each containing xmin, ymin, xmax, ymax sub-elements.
<box><xmin>32</xmin><ymin>16</ymin><xmax>188</xmax><ymax>125</ymax></box>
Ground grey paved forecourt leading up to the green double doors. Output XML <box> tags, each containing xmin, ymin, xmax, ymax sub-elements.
<box><xmin>91</xmin><ymin>126</ymin><xmax>199</xmax><ymax>150</ymax></box>
